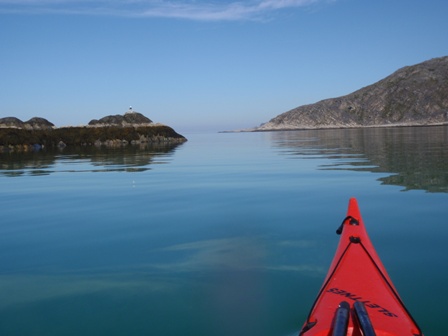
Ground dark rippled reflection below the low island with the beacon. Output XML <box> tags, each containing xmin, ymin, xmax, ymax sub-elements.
<box><xmin>0</xmin><ymin>144</ymin><xmax>182</xmax><ymax>177</ymax></box>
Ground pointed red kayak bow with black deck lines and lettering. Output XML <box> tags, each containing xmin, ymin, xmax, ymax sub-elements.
<box><xmin>300</xmin><ymin>198</ymin><xmax>423</xmax><ymax>336</ymax></box>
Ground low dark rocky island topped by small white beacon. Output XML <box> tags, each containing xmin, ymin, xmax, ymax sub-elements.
<box><xmin>0</xmin><ymin>109</ymin><xmax>187</xmax><ymax>152</ymax></box>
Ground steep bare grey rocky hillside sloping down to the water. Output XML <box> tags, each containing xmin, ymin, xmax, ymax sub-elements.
<box><xmin>254</xmin><ymin>56</ymin><xmax>448</xmax><ymax>131</ymax></box>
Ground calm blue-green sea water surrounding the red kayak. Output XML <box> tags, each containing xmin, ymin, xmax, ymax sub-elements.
<box><xmin>0</xmin><ymin>127</ymin><xmax>448</xmax><ymax>336</ymax></box>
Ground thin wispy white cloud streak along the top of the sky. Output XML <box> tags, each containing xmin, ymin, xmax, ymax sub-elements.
<box><xmin>0</xmin><ymin>0</ymin><xmax>324</xmax><ymax>21</ymax></box>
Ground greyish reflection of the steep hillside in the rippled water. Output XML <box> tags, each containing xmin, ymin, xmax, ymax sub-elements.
<box><xmin>271</xmin><ymin>126</ymin><xmax>448</xmax><ymax>193</ymax></box>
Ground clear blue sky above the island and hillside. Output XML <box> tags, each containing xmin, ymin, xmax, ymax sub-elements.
<box><xmin>0</xmin><ymin>0</ymin><xmax>448</xmax><ymax>133</ymax></box>
